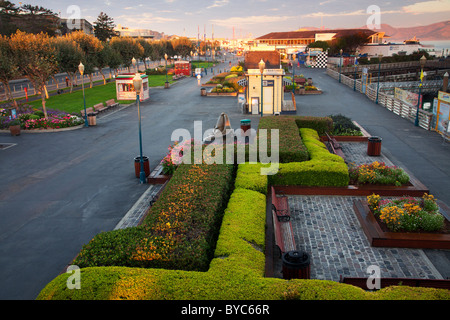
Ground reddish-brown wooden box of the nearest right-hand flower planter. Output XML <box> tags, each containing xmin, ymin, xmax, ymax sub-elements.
<box><xmin>353</xmin><ymin>201</ymin><xmax>450</xmax><ymax>249</ymax></box>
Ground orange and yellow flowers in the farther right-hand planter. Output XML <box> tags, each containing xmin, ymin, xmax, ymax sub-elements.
<box><xmin>349</xmin><ymin>161</ymin><xmax>409</xmax><ymax>186</ymax></box>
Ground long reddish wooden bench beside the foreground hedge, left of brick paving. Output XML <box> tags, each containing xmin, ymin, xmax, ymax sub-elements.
<box><xmin>272</xmin><ymin>187</ymin><xmax>297</xmax><ymax>256</ymax></box>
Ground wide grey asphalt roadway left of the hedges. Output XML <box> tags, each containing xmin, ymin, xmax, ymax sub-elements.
<box><xmin>0</xmin><ymin>56</ymin><xmax>250</xmax><ymax>299</ymax></box>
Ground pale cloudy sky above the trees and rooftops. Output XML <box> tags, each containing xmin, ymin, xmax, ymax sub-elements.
<box><xmin>11</xmin><ymin>0</ymin><xmax>450</xmax><ymax>39</ymax></box>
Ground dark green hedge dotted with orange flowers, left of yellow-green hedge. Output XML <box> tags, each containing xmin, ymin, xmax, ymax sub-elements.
<box><xmin>73</xmin><ymin>164</ymin><xmax>234</xmax><ymax>270</ymax></box>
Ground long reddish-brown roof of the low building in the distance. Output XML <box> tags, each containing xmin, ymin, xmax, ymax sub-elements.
<box><xmin>256</xmin><ymin>29</ymin><xmax>377</xmax><ymax>40</ymax></box>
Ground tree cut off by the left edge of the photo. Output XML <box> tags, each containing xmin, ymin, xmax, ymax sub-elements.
<box><xmin>0</xmin><ymin>35</ymin><xmax>19</xmax><ymax>106</ymax></box>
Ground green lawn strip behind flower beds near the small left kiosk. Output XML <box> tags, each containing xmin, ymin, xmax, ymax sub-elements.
<box><xmin>28</xmin><ymin>75</ymin><xmax>173</xmax><ymax>113</ymax></box>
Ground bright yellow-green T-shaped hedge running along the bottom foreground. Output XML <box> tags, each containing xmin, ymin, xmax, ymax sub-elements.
<box><xmin>38</xmin><ymin>165</ymin><xmax>450</xmax><ymax>300</ymax></box>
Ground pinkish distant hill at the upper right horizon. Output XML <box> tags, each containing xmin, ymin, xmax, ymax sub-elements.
<box><xmin>363</xmin><ymin>20</ymin><xmax>450</xmax><ymax>41</ymax></box>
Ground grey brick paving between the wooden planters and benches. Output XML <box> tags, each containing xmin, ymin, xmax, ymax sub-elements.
<box><xmin>274</xmin><ymin>142</ymin><xmax>443</xmax><ymax>281</ymax></box>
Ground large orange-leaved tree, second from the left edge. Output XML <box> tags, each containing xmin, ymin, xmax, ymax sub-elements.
<box><xmin>10</xmin><ymin>31</ymin><xmax>58</xmax><ymax>119</ymax></box>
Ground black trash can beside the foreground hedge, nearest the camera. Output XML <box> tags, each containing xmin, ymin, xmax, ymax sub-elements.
<box><xmin>281</xmin><ymin>251</ymin><xmax>310</xmax><ymax>280</ymax></box>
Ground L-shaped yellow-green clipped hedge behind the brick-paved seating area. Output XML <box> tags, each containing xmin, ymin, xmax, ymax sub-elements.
<box><xmin>269</xmin><ymin>128</ymin><xmax>349</xmax><ymax>187</ymax></box>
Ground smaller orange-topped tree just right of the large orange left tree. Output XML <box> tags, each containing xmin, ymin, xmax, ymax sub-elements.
<box><xmin>52</xmin><ymin>36</ymin><xmax>84</xmax><ymax>92</ymax></box>
